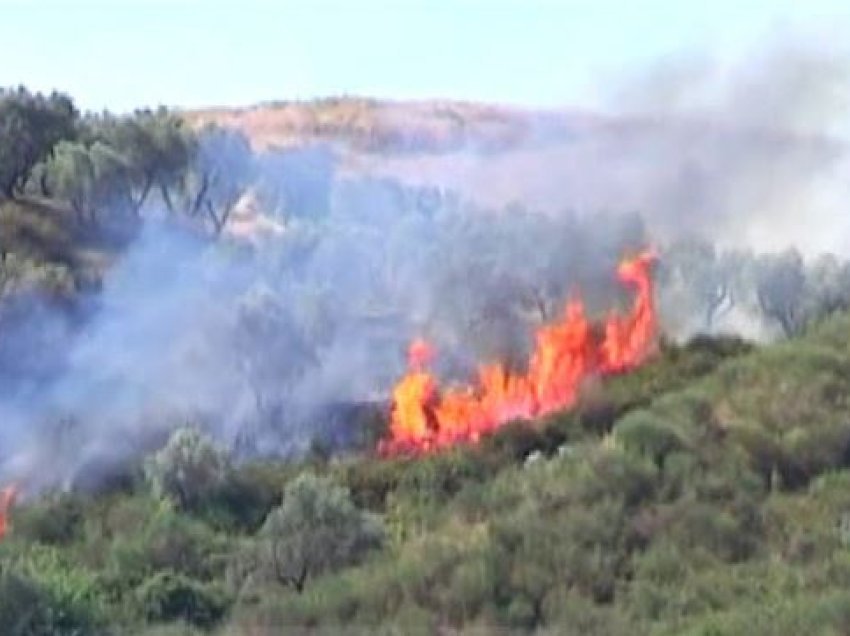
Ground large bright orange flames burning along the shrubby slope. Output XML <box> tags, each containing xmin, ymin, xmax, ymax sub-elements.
<box><xmin>379</xmin><ymin>251</ymin><xmax>657</xmax><ymax>454</ymax></box>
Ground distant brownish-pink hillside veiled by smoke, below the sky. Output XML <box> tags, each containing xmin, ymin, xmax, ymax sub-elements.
<box><xmin>184</xmin><ymin>98</ymin><xmax>846</xmax><ymax>253</ymax></box>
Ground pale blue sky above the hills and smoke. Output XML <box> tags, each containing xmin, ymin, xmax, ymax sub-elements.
<box><xmin>0</xmin><ymin>0</ymin><xmax>850</xmax><ymax>110</ymax></box>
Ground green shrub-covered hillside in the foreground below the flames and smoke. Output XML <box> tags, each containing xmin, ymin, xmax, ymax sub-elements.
<box><xmin>0</xmin><ymin>315</ymin><xmax>850</xmax><ymax>635</ymax></box>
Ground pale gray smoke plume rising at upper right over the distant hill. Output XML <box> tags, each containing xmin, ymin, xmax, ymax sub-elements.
<box><xmin>369</xmin><ymin>39</ymin><xmax>850</xmax><ymax>254</ymax></box>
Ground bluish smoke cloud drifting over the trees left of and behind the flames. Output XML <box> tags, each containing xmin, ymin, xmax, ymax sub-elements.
<box><xmin>0</xmin><ymin>179</ymin><xmax>645</xmax><ymax>488</ymax></box>
